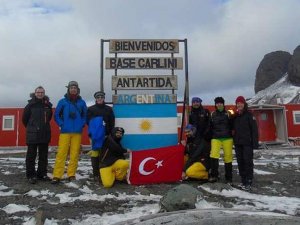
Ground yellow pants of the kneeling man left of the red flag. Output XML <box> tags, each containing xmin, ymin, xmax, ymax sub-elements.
<box><xmin>100</xmin><ymin>159</ymin><xmax>129</xmax><ymax>188</ymax></box>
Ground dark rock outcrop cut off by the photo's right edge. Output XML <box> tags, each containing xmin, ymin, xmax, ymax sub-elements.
<box><xmin>288</xmin><ymin>45</ymin><xmax>300</xmax><ymax>86</ymax></box>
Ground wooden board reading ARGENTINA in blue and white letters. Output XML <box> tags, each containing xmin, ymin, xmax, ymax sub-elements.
<box><xmin>113</xmin><ymin>94</ymin><xmax>177</xmax><ymax>104</ymax></box>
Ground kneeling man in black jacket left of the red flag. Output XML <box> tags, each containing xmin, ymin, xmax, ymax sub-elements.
<box><xmin>99</xmin><ymin>127</ymin><xmax>129</xmax><ymax>188</ymax></box>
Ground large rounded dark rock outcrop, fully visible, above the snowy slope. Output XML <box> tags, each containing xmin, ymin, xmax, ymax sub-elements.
<box><xmin>254</xmin><ymin>51</ymin><xmax>292</xmax><ymax>93</ymax></box>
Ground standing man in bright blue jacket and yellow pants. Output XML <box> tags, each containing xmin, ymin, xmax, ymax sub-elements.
<box><xmin>51</xmin><ymin>81</ymin><xmax>87</xmax><ymax>184</ymax></box>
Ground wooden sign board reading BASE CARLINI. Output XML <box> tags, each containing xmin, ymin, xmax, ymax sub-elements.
<box><xmin>105</xmin><ymin>57</ymin><xmax>183</xmax><ymax>70</ymax></box>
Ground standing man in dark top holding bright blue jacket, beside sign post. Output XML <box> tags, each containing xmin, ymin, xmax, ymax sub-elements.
<box><xmin>87</xmin><ymin>91</ymin><xmax>115</xmax><ymax>181</ymax></box>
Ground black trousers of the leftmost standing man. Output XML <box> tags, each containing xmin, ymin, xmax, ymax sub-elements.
<box><xmin>26</xmin><ymin>143</ymin><xmax>48</xmax><ymax>178</ymax></box>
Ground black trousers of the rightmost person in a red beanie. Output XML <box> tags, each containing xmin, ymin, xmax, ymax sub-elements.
<box><xmin>235</xmin><ymin>145</ymin><xmax>254</xmax><ymax>185</ymax></box>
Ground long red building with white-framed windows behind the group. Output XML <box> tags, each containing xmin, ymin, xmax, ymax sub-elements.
<box><xmin>0</xmin><ymin>104</ymin><xmax>300</xmax><ymax>147</ymax></box>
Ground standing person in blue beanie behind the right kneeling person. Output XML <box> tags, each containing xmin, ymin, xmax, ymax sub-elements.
<box><xmin>189</xmin><ymin>97</ymin><xmax>211</xmax><ymax>143</ymax></box>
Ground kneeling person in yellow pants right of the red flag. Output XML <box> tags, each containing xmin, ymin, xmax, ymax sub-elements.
<box><xmin>182</xmin><ymin>124</ymin><xmax>210</xmax><ymax>180</ymax></box>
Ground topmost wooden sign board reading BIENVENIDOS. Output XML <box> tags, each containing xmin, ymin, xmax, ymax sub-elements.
<box><xmin>109</xmin><ymin>39</ymin><xmax>179</xmax><ymax>53</ymax></box>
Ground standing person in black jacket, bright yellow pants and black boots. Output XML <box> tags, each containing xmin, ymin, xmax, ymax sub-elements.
<box><xmin>208</xmin><ymin>97</ymin><xmax>233</xmax><ymax>184</ymax></box>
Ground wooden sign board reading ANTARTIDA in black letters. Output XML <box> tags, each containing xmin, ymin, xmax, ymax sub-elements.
<box><xmin>111</xmin><ymin>75</ymin><xmax>177</xmax><ymax>90</ymax></box>
